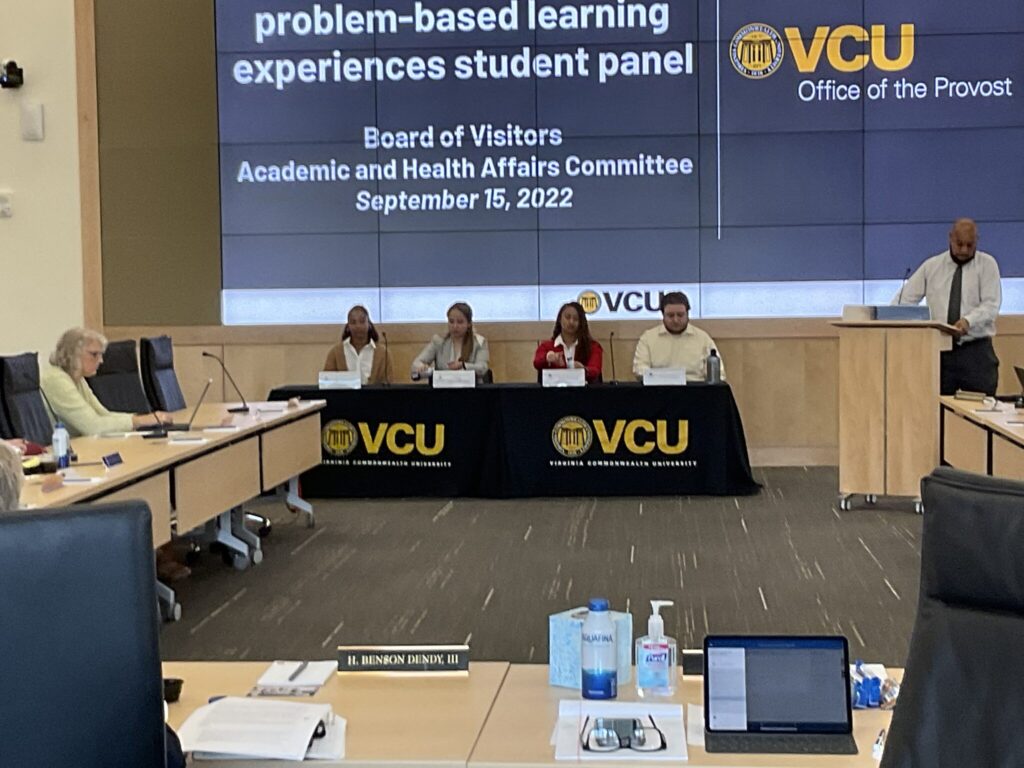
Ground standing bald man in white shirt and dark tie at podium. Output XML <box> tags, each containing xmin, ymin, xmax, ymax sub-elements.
<box><xmin>892</xmin><ymin>219</ymin><xmax>1002</xmax><ymax>394</ymax></box>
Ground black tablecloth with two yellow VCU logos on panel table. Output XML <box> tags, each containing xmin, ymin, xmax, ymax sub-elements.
<box><xmin>270</xmin><ymin>384</ymin><xmax>759</xmax><ymax>498</ymax></box>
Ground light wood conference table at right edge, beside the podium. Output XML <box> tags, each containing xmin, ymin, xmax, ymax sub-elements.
<box><xmin>939</xmin><ymin>395</ymin><xmax>1024</xmax><ymax>480</ymax></box>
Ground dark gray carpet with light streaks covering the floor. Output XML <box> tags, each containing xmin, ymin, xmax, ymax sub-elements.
<box><xmin>161</xmin><ymin>468</ymin><xmax>922</xmax><ymax>666</ymax></box>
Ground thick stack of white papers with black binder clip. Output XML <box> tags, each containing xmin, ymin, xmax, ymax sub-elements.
<box><xmin>178</xmin><ymin>696</ymin><xmax>345</xmax><ymax>760</ymax></box>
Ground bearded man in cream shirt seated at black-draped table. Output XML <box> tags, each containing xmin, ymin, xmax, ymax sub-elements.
<box><xmin>633</xmin><ymin>291</ymin><xmax>725</xmax><ymax>381</ymax></box>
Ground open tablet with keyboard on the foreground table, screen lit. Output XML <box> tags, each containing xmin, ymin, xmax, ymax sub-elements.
<box><xmin>703</xmin><ymin>635</ymin><xmax>857</xmax><ymax>755</ymax></box>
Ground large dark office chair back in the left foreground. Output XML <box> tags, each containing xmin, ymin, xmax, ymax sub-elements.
<box><xmin>0</xmin><ymin>502</ymin><xmax>165</xmax><ymax>768</ymax></box>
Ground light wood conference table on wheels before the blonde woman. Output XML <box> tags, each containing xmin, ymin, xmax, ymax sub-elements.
<box><xmin>20</xmin><ymin>400</ymin><xmax>324</xmax><ymax>620</ymax></box>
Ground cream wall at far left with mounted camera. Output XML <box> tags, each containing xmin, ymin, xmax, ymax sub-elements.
<box><xmin>0</xmin><ymin>0</ymin><xmax>83</xmax><ymax>354</ymax></box>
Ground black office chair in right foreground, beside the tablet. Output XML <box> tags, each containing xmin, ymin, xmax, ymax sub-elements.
<box><xmin>882</xmin><ymin>468</ymin><xmax>1024</xmax><ymax>768</ymax></box>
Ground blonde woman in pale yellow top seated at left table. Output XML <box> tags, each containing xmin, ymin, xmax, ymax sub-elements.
<box><xmin>39</xmin><ymin>328</ymin><xmax>171</xmax><ymax>437</ymax></box>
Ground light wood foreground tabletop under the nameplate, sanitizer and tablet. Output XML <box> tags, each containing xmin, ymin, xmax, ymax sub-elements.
<box><xmin>164</xmin><ymin>662</ymin><xmax>899</xmax><ymax>768</ymax></box>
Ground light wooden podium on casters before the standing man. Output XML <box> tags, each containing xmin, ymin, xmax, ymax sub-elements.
<box><xmin>833</xmin><ymin>321</ymin><xmax>953</xmax><ymax>512</ymax></box>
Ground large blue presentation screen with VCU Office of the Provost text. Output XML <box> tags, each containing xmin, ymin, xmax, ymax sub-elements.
<box><xmin>216</xmin><ymin>0</ymin><xmax>1024</xmax><ymax>325</ymax></box>
